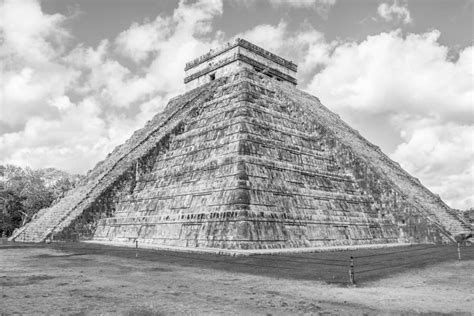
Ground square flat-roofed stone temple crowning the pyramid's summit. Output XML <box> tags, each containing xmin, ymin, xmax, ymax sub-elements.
<box><xmin>184</xmin><ymin>38</ymin><xmax>297</xmax><ymax>90</ymax></box>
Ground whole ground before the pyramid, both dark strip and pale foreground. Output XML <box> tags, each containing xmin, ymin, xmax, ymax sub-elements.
<box><xmin>0</xmin><ymin>243</ymin><xmax>474</xmax><ymax>315</ymax></box>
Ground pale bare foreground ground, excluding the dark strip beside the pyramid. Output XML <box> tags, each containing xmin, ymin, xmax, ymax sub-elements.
<box><xmin>0</xmin><ymin>248</ymin><xmax>474</xmax><ymax>315</ymax></box>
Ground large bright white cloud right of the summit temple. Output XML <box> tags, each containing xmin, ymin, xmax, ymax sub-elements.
<box><xmin>310</xmin><ymin>30</ymin><xmax>473</xmax><ymax>120</ymax></box>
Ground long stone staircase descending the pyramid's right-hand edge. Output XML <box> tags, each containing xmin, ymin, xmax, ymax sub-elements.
<box><xmin>276</xmin><ymin>73</ymin><xmax>472</xmax><ymax>241</ymax></box>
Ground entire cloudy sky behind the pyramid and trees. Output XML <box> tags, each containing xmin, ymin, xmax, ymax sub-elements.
<box><xmin>0</xmin><ymin>0</ymin><xmax>474</xmax><ymax>209</ymax></box>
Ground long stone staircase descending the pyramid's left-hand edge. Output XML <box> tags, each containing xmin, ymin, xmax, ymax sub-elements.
<box><xmin>9</xmin><ymin>79</ymin><xmax>225</xmax><ymax>242</ymax></box>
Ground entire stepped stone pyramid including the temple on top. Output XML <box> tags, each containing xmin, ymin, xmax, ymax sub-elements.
<box><xmin>11</xmin><ymin>39</ymin><xmax>472</xmax><ymax>250</ymax></box>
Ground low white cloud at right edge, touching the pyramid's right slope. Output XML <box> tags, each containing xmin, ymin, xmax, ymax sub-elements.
<box><xmin>393</xmin><ymin>122</ymin><xmax>474</xmax><ymax>209</ymax></box>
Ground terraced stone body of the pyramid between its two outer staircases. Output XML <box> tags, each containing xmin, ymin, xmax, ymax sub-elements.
<box><xmin>79</xmin><ymin>71</ymin><xmax>450</xmax><ymax>249</ymax></box>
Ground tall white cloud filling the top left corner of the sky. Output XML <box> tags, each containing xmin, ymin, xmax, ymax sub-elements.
<box><xmin>0</xmin><ymin>0</ymin><xmax>78</xmax><ymax>130</ymax></box>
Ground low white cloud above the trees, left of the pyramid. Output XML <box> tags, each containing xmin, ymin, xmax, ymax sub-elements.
<box><xmin>0</xmin><ymin>99</ymin><xmax>112</xmax><ymax>172</ymax></box>
